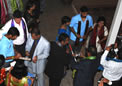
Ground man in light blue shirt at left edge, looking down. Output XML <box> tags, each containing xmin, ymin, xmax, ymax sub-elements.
<box><xmin>0</xmin><ymin>27</ymin><xmax>20</xmax><ymax>67</ymax></box>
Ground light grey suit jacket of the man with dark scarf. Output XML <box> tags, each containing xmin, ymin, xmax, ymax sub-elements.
<box><xmin>26</xmin><ymin>35</ymin><xmax>50</xmax><ymax>59</ymax></box>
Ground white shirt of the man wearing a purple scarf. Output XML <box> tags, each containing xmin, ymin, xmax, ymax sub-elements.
<box><xmin>0</xmin><ymin>18</ymin><xmax>28</xmax><ymax>45</ymax></box>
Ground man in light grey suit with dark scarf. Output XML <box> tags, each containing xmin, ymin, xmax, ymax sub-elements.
<box><xmin>25</xmin><ymin>28</ymin><xmax>50</xmax><ymax>86</ymax></box>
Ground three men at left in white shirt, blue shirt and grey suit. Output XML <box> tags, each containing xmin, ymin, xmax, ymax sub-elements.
<box><xmin>0</xmin><ymin>10</ymin><xmax>50</xmax><ymax>86</ymax></box>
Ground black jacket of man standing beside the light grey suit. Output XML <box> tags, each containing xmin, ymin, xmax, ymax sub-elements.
<box><xmin>45</xmin><ymin>42</ymin><xmax>70</xmax><ymax>78</ymax></box>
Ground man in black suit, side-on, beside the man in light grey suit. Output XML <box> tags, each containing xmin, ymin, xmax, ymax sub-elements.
<box><xmin>45</xmin><ymin>33</ymin><xmax>70</xmax><ymax>86</ymax></box>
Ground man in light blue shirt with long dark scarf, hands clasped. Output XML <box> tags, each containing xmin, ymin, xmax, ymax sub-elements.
<box><xmin>70</xmin><ymin>6</ymin><xmax>93</xmax><ymax>53</ymax></box>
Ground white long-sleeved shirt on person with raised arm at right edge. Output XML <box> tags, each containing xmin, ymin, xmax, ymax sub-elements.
<box><xmin>100</xmin><ymin>50</ymin><xmax>122</xmax><ymax>81</ymax></box>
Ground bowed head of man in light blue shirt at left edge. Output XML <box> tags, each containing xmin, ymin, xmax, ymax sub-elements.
<box><xmin>7</xmin><ymin>27</ymin><xmax>20</xmax><ymax>40</ymax></box>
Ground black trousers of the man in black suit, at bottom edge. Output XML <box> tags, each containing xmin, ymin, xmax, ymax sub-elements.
<box><xmin>49</xmin><ymin>76</ymin><xmax>62</xmax><ymax>86</ymax></box>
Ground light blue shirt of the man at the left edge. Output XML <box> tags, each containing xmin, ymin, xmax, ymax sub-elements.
<box><xmin>0</xmin><ymin>35</ymin><xmax>14</xmax><ymax>62</ymax></box>
